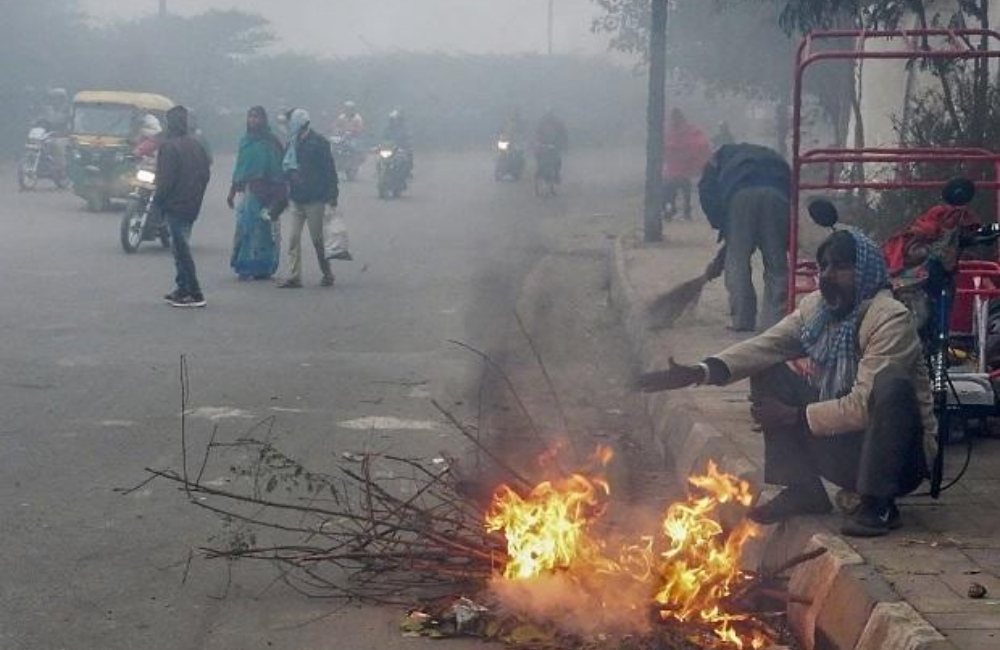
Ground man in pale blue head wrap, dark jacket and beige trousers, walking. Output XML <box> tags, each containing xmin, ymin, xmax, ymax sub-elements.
<box><xmin>278</xmin><ymin>108</ymin><xmax>339</xmax><ymax>289</ymax></box>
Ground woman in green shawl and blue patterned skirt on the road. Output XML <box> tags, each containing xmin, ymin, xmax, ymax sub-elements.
<box><xmin>226</xmin><ymin>106</ymin><xmax>288</xmax><ymax>280</ymax></box>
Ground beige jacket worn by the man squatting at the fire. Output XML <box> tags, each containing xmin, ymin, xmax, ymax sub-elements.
<box><xmin>712</xmin><ymin>290</ymin><xmax>937</xmax><ymax>463</ymax></box>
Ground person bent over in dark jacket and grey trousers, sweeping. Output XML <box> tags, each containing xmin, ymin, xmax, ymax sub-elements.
<box><xmin>698</xmin><ymin>143</ymin><xmax>791</xmax><ymax>332</ymax></box>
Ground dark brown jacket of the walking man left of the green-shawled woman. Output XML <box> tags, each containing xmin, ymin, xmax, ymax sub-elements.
<box><xmin>153</xmin><ymin>132</ymin><xmax>211</xmax><ymax>221</ymax></box>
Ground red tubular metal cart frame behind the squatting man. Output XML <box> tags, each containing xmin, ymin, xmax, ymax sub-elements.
<box><xmin>787</xmin><ymin>29</ymin><xmax>1000</xmax><ymax>311</ymax></box>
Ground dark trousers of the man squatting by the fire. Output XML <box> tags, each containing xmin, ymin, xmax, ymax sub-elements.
<box><xmin>750</xmin><ymin>363</ymin><xmax>928</xmax><ymax>497</ymax></box>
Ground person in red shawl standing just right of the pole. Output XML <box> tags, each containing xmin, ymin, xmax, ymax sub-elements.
<box><xmin>663</xmin><ymin>108</ymin><xmax>712</xmax><ymax>220</ymax></box>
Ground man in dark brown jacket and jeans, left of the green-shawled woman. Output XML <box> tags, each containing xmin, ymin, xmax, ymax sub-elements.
<box><xmin>153</xmin><ymin>106</ymin><xmax>211</xmax><ymax>307</ymax></box>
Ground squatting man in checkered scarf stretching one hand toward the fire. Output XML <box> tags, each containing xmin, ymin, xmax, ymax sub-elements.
<box><xmin>638</xmin><ymin>230</ymin><xmax>937</xmax><ymax>537</ymax></box>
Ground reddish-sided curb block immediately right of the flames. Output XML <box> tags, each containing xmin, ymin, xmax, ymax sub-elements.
<box><xmin>788</xmin><ymin>533</ymin><xmax>864</xmax><ymax>650</ymax></box>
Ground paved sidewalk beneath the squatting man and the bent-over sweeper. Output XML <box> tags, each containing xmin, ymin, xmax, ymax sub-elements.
<box><xmin>610</xmin><ymin>222</ymin><xmax>1000</xmax><ymax>650</ymax></box>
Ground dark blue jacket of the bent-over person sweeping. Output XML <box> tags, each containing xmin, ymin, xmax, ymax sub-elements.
<box><xmin>698</xmin><ymin>142</ymin><xmax>791</xmax><ymax>237</ymax></box>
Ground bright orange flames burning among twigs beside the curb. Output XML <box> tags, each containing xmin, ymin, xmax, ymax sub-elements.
<box><xmin>486</xmin><ymin>448</ymin><xmax>769</xmax><ymax>650</ymax></box>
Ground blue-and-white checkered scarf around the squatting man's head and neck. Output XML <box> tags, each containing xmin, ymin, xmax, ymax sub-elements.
<box><xmin>802</xmin><ymin>228</ymin><xmax>889</xmax><ymax>400</ymax></box>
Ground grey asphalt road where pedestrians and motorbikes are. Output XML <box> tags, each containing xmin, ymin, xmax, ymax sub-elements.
<box><xmin>0</xmin><ymin>152</ymin><xmax>641</xmax><ymax>650</ymax></box>
